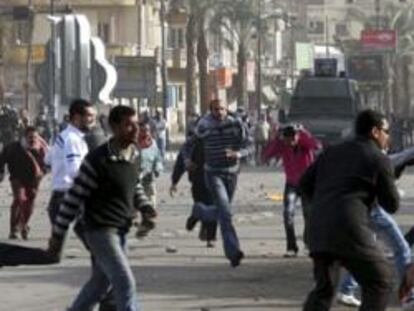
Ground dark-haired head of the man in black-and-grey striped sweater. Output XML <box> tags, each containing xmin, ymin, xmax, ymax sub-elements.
<box><xmin>108</xmin><ymin>106</ymin><xmax>138</xmax><ymax>145</ymax></box>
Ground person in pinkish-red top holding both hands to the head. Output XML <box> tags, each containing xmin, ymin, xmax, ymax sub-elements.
<box><xmin>263</xmin><ymin>125</ymin><xmax>322</xmax><ymax>257</ymax></box>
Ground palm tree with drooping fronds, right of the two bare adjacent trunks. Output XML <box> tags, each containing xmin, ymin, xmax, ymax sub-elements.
<box><xmin>211</xmin><ymin>0</ymin><xmax>257</xmax><ymax>107</ymax></box>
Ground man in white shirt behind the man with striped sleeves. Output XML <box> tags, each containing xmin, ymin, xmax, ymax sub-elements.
<box><xmin>48</xmin><ymin>99</ymin><xmax>96</xmax><ymax>225</ymax></box>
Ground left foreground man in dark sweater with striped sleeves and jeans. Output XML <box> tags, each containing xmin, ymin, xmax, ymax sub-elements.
<box><xmin>49</xmin><ymin>106</ymin><xmax>152</xmax><ymax>311</ymax></box>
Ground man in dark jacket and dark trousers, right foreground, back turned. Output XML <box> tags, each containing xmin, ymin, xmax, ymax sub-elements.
<box><xmin>300</xmin><ymin>110</ymin><xmax>399</xmax><ymax>311</ymax></box>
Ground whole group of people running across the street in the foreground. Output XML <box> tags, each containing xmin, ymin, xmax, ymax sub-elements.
<box><xmin>0</xmin><ymin>99</ymin><xmax>414</xmax><ymax>311</ymax></box>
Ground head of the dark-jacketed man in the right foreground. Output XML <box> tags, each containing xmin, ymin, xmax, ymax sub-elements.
<box><xmin>355</xmin><ymin>109</ymin><xmax>390</xmax><ymax>150</ymax></box>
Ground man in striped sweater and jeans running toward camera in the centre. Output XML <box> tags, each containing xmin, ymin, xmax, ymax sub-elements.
<box><xmin>184</xmin><ymin>100</ymin><xmax>253</xmax><ymax>267</ymax></box>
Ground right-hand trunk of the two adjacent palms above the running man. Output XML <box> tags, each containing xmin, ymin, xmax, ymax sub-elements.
<box><xmin>197</xmin><ymin>15</ymin><xmax>209</xmax><ymax>113</ymax></box>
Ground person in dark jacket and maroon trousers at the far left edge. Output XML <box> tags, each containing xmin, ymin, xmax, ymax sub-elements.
<box><xmin>0</xmin><ymin>126</ymin><xmax>48</xmax><ymax>240</ymax></box>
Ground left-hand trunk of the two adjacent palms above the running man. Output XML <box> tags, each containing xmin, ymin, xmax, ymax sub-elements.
<box><xmin>185</xmin><ymin>12</ymin><xmax>197</xmax><ymax>124</ymax></box>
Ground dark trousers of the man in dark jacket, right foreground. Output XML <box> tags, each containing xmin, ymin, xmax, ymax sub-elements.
<box><xmin>303</xmin><ymin>253</ymin><xmax>392</xmax><ymax>311</ymax></box>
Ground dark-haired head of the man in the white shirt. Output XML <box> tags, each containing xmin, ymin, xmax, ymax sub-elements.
<box><xmin>69</xmin><ymin>99</ymin><xmax>96</xmax><ymax>131</ymax></box>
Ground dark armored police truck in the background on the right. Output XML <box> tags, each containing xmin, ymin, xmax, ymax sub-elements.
<box><xmin>288</xmin><ymin>59</ymin><xmax>362</xmax><ymax>145</ymax></box>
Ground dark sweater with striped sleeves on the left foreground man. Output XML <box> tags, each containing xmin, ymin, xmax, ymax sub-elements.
<box><xmin>53</xmin><ymin>143</ymin><xmax>151</xmax><ymax>238</ymax></box>
